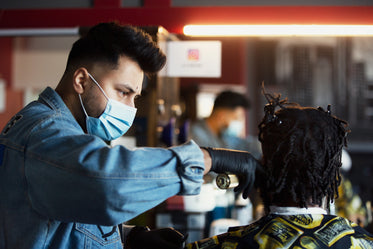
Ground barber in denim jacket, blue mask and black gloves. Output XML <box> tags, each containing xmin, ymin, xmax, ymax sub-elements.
<box><xmin>0</xmin><ymin>23</ymin><xmax>256</xmax><ymax>249</ymax></box>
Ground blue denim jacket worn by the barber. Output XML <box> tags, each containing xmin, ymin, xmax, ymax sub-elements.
<box><xmin>0</xmin><ymin>87</ymin><xmax>204</xmax><ymax>249</ymax></box>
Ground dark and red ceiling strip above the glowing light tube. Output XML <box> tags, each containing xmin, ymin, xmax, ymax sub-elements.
<box><xmin>0</xmin><ymin>0</ymin><xmax>373</xmax><ymax>33</ymax></box>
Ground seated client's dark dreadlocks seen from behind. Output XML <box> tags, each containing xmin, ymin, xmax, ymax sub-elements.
<box><xmin>257</xmin><ymin>88</ymin><xmax>350</xmax><ymax>212</ymax></box>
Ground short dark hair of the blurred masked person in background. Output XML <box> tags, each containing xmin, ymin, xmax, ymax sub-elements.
<box><xmin>213</xmin><ymin>91</ymin><xmax>250</xmax><ymax>110</ymax></box>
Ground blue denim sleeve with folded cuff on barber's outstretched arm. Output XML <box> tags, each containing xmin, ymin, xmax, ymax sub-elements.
<box><xmin>25</xmin><ymin>114</ymin><xmax>204</xmax><ymax>226</ymax></box>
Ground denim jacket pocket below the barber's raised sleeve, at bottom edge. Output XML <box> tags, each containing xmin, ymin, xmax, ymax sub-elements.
<box><xmin>75</xmin><ymin>223</ymin><xmax>122</xmax><ymax>249</ymax></box>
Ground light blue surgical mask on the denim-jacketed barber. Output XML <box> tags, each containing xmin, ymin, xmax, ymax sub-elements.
<box><xmin>79</xmin><ymin>74</ymin><xmax>137</xmax><ymax>141</ymax></box>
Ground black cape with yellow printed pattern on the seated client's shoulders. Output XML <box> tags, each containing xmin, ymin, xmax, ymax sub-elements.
<box><xmin>186</xmin><ymin>214</ymin><xmax>373</xmax><ymax>249</ymax></box>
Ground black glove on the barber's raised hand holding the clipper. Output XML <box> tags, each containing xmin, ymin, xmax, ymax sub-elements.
<box><xmin>202</xmin><ymin>147</ymin><xmax>259</xmax><ymax>199</ymax></box>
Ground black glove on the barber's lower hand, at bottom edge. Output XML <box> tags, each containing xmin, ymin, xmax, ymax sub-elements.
<box><xmin>126</xmin><ymin>226</ymin><xmax>188</xmax><ymax>249</ymax></box>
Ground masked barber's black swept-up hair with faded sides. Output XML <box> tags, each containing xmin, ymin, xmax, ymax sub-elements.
<box><xmin>66</xmin><ymin>22</ymin><xmax>166</xmax><ymax>77</ymax></box>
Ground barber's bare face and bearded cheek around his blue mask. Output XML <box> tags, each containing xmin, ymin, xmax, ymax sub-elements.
<box><xmin>82</xmin><ymin>56</ymin><xmax>144</xmax><ymax>117</ymax></box>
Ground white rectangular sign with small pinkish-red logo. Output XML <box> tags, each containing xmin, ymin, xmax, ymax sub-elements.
<box><xmin>166</xmin><ymin>41</ymin><xmax>221</xmax><ymax>78</ymax></box>
